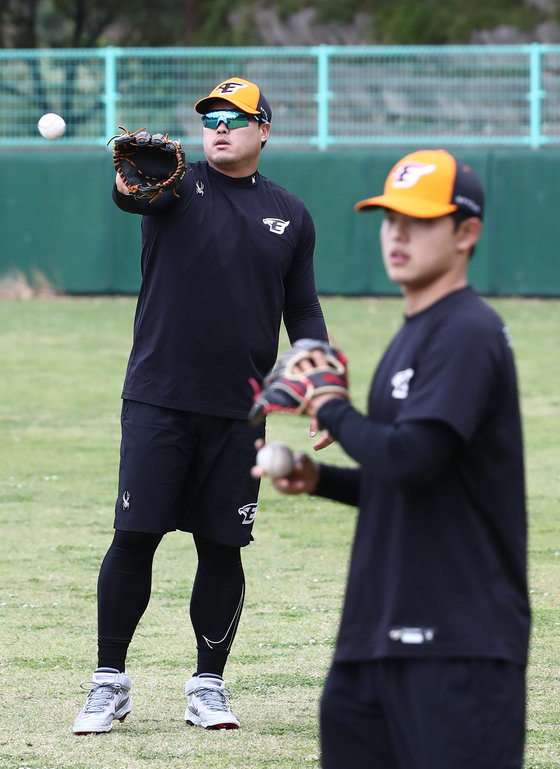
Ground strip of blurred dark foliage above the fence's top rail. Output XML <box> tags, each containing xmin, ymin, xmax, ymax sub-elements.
<box><xmin>0</xmin><ymin>0</ymin><xmax>560</xmax><ymax>48</ymax></box>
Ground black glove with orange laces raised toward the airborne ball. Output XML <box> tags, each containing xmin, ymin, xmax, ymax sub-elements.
<box><xmin>107</xmin><ymin>126</ymin><xmax>187</xmax><ymax>203</ymax></box>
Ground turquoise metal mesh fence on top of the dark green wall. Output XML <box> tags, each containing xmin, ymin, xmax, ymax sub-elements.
<box><xmin>0</xmin><ymin>43</ymin><xmax>560</xmax><ymax>150</ymax></box>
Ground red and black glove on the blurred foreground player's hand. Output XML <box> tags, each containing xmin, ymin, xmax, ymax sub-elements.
<box><xmin>248</xmin><ymin>339</ymin><xmax>348</xmax><ymax>425</ymax></box>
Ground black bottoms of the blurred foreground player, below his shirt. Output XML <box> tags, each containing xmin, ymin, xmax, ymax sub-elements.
<box><xmin>321</xmin><ymin>659</ymin><xmax>525</xmax><ymax>769</ymax></box>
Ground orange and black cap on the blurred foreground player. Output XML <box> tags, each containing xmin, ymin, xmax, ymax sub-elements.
<box><xmin>354</xmin><ymin>150</ymin><xmax>484</xmax><ymax>219</ymax></box>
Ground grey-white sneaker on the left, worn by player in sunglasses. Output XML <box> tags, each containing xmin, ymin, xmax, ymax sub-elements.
<box><xmin>73</xmin><ymin>668</ymin><xmax>132</xmax><ymax>734</ymax></box>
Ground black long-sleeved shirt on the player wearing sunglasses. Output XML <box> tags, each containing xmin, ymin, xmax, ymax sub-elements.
<box><xmin>113</xmin><ymin>161</ymin><xmax>327</xmax><ymax>419</ymax></box>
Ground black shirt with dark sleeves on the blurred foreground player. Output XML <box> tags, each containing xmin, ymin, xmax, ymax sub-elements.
<box><xmin>317</xmin><ymin>287</ymin><xmax>530</xmax><ymax>665</ymax></box>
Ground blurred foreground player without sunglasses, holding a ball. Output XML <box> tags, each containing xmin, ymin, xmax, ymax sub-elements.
<box><xmin>252</xmin><ymin>150</ymin><xmax>530</xmax><ymax>769</ymax></box>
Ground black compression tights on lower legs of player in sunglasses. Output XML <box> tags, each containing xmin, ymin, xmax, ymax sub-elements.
<box><xmin>97</xmin><ymin>530</ymin><xmax>245</xmax><ymax>675</ymax></box>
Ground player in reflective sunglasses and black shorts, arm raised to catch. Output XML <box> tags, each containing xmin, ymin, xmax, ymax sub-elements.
<box><xmin>74</xmin><ymin>77</ymin><xmax>329</xmax><ymax>734</ymax></box>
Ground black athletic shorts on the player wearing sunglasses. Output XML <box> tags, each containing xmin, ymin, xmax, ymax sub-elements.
<box><xmin>114</xmin><ymin>400</ymin><xmax>264</xmax><ymax>547</ymax></box>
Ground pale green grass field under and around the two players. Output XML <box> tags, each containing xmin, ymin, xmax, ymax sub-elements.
<box><xmin>0</xmin><ymin>297</ymin><xmax>560</xmax><ymax>769</ymax></box>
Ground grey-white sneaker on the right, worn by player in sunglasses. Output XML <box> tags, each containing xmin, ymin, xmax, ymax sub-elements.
<box><xmin>185</xmin><ymin>673</ymin><xmax>239</xmax><ymax>729</ymax></box>
